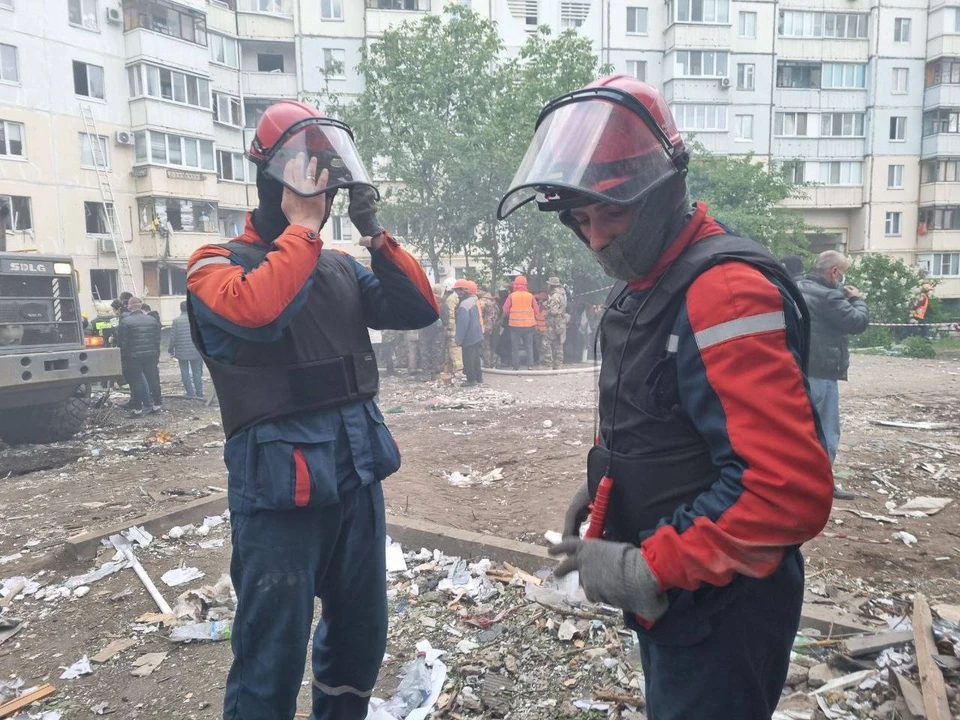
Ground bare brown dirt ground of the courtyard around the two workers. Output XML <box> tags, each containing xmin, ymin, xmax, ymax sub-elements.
<box><xmin>0</xmin><ymin>355</ymin><xmax>960</xmax><ymax>718</ymax></box>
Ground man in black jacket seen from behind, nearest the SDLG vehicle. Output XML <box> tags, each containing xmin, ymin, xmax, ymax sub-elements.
<box><xmin>117</xmin><ymin>297</ymin><xmax>161</xmax><ymax>417</ymax></box>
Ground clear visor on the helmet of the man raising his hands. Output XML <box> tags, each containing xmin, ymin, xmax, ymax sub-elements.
<box><xmin>260</xmin><ymin>118</ymin><xmax>373</xmax><ymax>197</ymax></box>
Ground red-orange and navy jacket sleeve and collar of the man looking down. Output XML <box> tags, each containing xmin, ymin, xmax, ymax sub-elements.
<box><xmin>630</xmin><ymin>203</ymin><xmax>833</xmax><ymax>591</ymax></box>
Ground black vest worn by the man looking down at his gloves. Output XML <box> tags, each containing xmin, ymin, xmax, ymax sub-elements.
<box><xmin>587</xmin><ymin>235</ymin><xmax>810</xmax><ymax>544</ymax></box>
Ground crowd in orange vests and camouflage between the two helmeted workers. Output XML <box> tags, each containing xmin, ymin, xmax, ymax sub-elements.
<box><xmin>380</xmin><ymin>275</ymin><xmax>599</xmax><ymax>386</ymax></box>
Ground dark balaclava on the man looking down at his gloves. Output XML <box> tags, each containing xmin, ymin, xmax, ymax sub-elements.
<box><xmin>560</xmin><ymin>173</ymin><xmax>694</xmax><ymax>281</ymax></box>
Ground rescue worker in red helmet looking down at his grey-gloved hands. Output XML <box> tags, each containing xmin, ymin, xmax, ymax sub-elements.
<box><xmin>499</xmin><ymin>75</ymin><xmax>833</xmax><ymax>720</ymax></box>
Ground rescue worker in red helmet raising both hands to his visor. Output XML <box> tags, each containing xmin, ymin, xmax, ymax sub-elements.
<box><xmin>187</xmin><ymin>100</ymin><xmax>439</xmax><ymax>720</ymax></box>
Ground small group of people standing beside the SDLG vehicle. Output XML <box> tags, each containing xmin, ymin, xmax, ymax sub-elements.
<box><xmin>86</xmin><ymin>292</ymin><xmax>203</xmax><ymax>417</ymax></box>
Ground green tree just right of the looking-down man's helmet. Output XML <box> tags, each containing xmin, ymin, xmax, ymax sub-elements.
<box><xmin>687</xmin><ymin>142</ymin><xmax>810</xmax><ymax>257</ymax></box>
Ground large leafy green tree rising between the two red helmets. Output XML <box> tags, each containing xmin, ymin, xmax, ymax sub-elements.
<box><xmin>341</xmin><ymin>5</ymin><xmax>603</xmax><ymax>288</ymax></box>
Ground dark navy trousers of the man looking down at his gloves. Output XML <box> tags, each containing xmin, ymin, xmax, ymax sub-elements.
<box><xmin>640</xmin><ymin>550</ymin><xmax>803</xmax><ymax>720</ymax></box>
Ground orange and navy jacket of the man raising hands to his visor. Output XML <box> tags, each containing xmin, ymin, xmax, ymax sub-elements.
<box><xmin>187</xmin><ymin>215</ymin><xmax>439</xmax><ymax>513</ymax></box>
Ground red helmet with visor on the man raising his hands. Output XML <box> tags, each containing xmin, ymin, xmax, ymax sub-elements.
<box><xmin>248</xmin><ymin>100</ymin><xmax>379</xmax><ymax>199</ymax></box>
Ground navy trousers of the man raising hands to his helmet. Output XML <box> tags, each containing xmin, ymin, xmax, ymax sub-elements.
<box><xmin>224</xmin><ymin>482</ymin><xmax>387</xmax><ymax>720</ymax></box>
